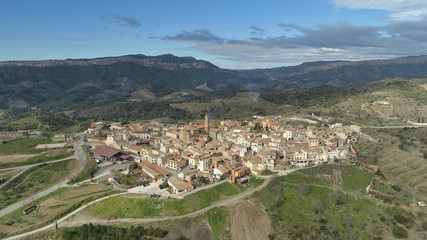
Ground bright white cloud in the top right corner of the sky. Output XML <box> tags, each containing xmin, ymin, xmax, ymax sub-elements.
<box><xmin>331</xmin><ymin>0</ymin><xmax>427</xmax><ymax>20</ymax></box>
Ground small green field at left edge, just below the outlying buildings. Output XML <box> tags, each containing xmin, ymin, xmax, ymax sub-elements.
<box><xmin>0</xmin><ymin>138</ymin><xmax>52</xmax><ymax>154</ymax></box>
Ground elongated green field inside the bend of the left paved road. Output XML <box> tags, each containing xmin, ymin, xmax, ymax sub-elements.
<box><xmin>0</xmin><ymin>159</ymin><xmax>77</xmax><ymax>208</ymax></box>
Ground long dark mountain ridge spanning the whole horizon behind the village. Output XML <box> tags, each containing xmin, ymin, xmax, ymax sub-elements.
<box><xmin>0</xmin><ymin>54</ymin><xmax>427</xmax><ymax>111</ymax></box>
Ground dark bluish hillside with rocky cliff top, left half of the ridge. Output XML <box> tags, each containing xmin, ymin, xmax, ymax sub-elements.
<box><xmin>0</xmin><ymin>55</ymin><xmax>238</xmax><ymax>110</ymax></box>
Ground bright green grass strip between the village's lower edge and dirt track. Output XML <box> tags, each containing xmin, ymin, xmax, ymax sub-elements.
<box><xmin>87</xmin><ymin>182</ymin><xmax>249</xmax><ymax>218</ymax></box>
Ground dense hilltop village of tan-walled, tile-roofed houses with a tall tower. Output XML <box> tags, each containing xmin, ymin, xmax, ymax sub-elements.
<box><xmin>86</xmin><ymin>115</ymin><xmax>360</xmax><ymax>194</ymax></box>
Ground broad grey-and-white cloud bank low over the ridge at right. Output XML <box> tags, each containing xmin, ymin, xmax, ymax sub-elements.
<box><xmin>162</xmin><ymin>11</ymin><xmax>427</xmax><ymax>66</ymax></box>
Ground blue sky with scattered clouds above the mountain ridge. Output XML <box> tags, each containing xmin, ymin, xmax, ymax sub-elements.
<box><xmin>0</xmin><ymin>0</ymin><xmax>427</xmax><ymax>69</ymax></box>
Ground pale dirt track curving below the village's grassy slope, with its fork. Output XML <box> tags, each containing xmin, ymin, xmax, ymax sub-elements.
<box><xmin>5</xmin><ymin>176</ymin><xmax>271</xmax><ymax>240</ymax></box>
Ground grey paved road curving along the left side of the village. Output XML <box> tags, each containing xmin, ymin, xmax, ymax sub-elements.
<box><xmin>0</xmin><ymin>137</ymin><xmax>86</xmax><ymax>217</ymax></box>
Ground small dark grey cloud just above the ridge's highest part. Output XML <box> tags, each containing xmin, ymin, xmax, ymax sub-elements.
<box><xmin>162</xmin><ymin>29</ymin><xmax>224</xmax><ymax>44</ymax></box>
